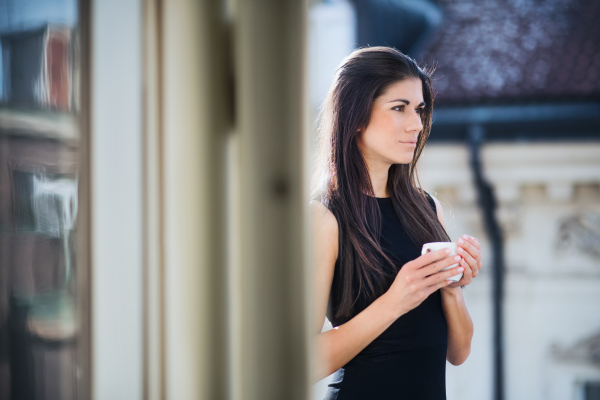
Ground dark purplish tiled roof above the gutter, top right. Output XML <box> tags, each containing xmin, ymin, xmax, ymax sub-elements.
<box><xmin>423</xmin><ymin>0</ymin><xmax>600</xmax><ymax>103</ymax></box>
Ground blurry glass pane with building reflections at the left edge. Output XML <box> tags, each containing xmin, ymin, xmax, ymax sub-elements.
<box><xmin>0</xmin><ymin>0</ymin><xmax>80</xmax><ymax>400</ymax></box>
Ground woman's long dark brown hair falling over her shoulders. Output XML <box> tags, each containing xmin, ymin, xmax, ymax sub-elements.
<box><xmin>312</xmin><ymin>47</ymin><xmax>449</xmax><ymax>319</ymax></box>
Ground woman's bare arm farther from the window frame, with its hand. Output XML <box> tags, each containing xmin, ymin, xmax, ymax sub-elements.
<box><xmin>434</xmin><ymin>198</ymin><xmax>481</xmax><ymax>365</ymax></box>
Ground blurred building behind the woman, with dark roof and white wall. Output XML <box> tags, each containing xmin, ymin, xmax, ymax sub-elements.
<box><xmin>309</xmin><ymin>0</ymin><xmax>600</xmax><ymax>400</ymax></box>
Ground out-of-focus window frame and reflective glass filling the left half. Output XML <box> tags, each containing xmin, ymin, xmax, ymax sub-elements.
<box><xmin>0</xmin><ymin>0</ymin><xmax>309</xmax><ymax>400</ymax></box>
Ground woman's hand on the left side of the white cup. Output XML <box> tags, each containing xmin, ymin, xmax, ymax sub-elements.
<box><xmin>384</xmin><ymin>249</ymin><xmax>464</xmax><ymax>317</ymax></box>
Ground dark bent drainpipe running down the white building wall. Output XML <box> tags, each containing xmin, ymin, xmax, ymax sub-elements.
<box><xmin>468</xmin><ymin>125</ymin><xmax>504</xmax><ymax>400</ymax></box>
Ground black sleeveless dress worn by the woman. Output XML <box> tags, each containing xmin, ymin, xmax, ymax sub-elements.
<box><xmin>324</xmin><ymin>195</ymin><xmax>448</xmax><ymax>400</ymax></box>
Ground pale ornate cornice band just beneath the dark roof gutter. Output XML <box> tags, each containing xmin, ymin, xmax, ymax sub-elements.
<box><xmin>419</xmin><ymin>142</ymin><xmax>600</xmax><ymax>206</ymax></box>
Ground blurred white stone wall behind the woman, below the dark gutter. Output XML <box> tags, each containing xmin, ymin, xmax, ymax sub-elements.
<box><xmin>419</xmin><ymin>143</ymin><xmax>600</xmax><ymax>400</ymax></box>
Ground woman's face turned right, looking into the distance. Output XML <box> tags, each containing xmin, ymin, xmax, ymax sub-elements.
<box><xmin>358</xmin><ymin>79</ymin><xmax>425</xmax><ymax>165</ymax></box>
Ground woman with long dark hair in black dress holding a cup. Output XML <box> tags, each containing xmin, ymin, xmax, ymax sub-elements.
<box><xmin>311</xmin><ymin>47</ymin><xmax>481</xmax><ymax>400</ymax></box>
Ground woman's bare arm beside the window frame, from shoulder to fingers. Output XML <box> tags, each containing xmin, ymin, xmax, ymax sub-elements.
<box><xmin>311</xmin><ymin>201</ymin><xmax>462</xmax><ymax>382</ymax></box>
